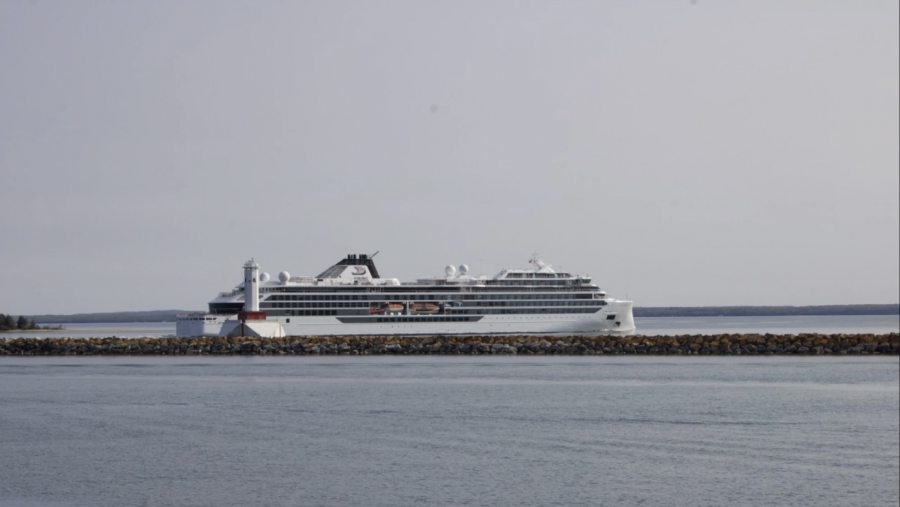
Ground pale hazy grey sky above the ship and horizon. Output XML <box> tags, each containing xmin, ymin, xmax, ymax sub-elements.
<box><xmin>0</xmin><ymin>0</ymin><xmax>900</xmax><ymax>315</ymax></box>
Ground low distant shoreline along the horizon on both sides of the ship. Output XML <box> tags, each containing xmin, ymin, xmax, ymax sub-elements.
<box><xmin>21</xmin><ymin>304</ymin><xmax>900</xmax><ymax>325</ymax></box>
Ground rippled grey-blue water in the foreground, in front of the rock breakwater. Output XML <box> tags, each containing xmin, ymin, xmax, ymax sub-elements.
<box><xmin>0</xmin><ymin>356</ymin><xmax>900</xmax><ymax>507</ymax></box>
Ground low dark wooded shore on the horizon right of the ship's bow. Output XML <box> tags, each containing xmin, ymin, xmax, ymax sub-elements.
<box><xmin>634</xmin><ymin>304</ymin><xmax>900</xmax><ymax>317</ymax></box>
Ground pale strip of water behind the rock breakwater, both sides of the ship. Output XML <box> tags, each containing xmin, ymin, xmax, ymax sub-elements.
<box><xmin>0</xmin><ymin>315</ymin><xmax>900</xmax><ymax>338</ymax></box>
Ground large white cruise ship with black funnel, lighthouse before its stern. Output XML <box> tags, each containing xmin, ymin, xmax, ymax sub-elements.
<box><xmin>176</xmin><ymin>252</ymin><xmax>635</xmax><ymax>337</ymax></box>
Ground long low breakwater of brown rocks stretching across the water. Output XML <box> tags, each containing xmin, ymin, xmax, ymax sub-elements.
<box><xmin>0</xmin><ymin>333</ymin><xmax>900</xmax><ymax>356</ymax></box>
